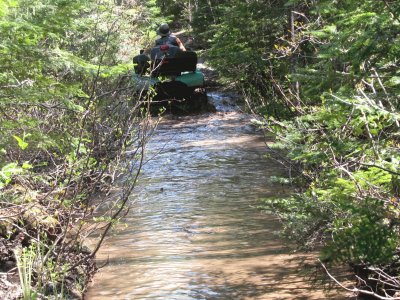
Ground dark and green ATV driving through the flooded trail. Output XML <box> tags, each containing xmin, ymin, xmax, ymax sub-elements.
<box><xmin>132</xmin><ymin>45</ymin><xmax>207</xmax><ymax>106</ymax></box>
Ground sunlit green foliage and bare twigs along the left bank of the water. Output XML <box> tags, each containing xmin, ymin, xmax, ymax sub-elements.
<box><xmin>0</xmin><ymin>0</ymin><xmax>154</xmax><ymax>299</ymax></box>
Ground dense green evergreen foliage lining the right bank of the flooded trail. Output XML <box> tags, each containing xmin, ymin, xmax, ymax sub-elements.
<box><xmin>199</xmin><ymin>0</ymin><xmax>400</xmax><ymax>295</ymax></box>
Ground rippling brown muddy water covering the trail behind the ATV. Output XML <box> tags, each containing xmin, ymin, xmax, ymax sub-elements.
<box><xmin>87</xmin><ymin>94</ymin><xmax>334</xmax><ymax>300</ymax></box>
